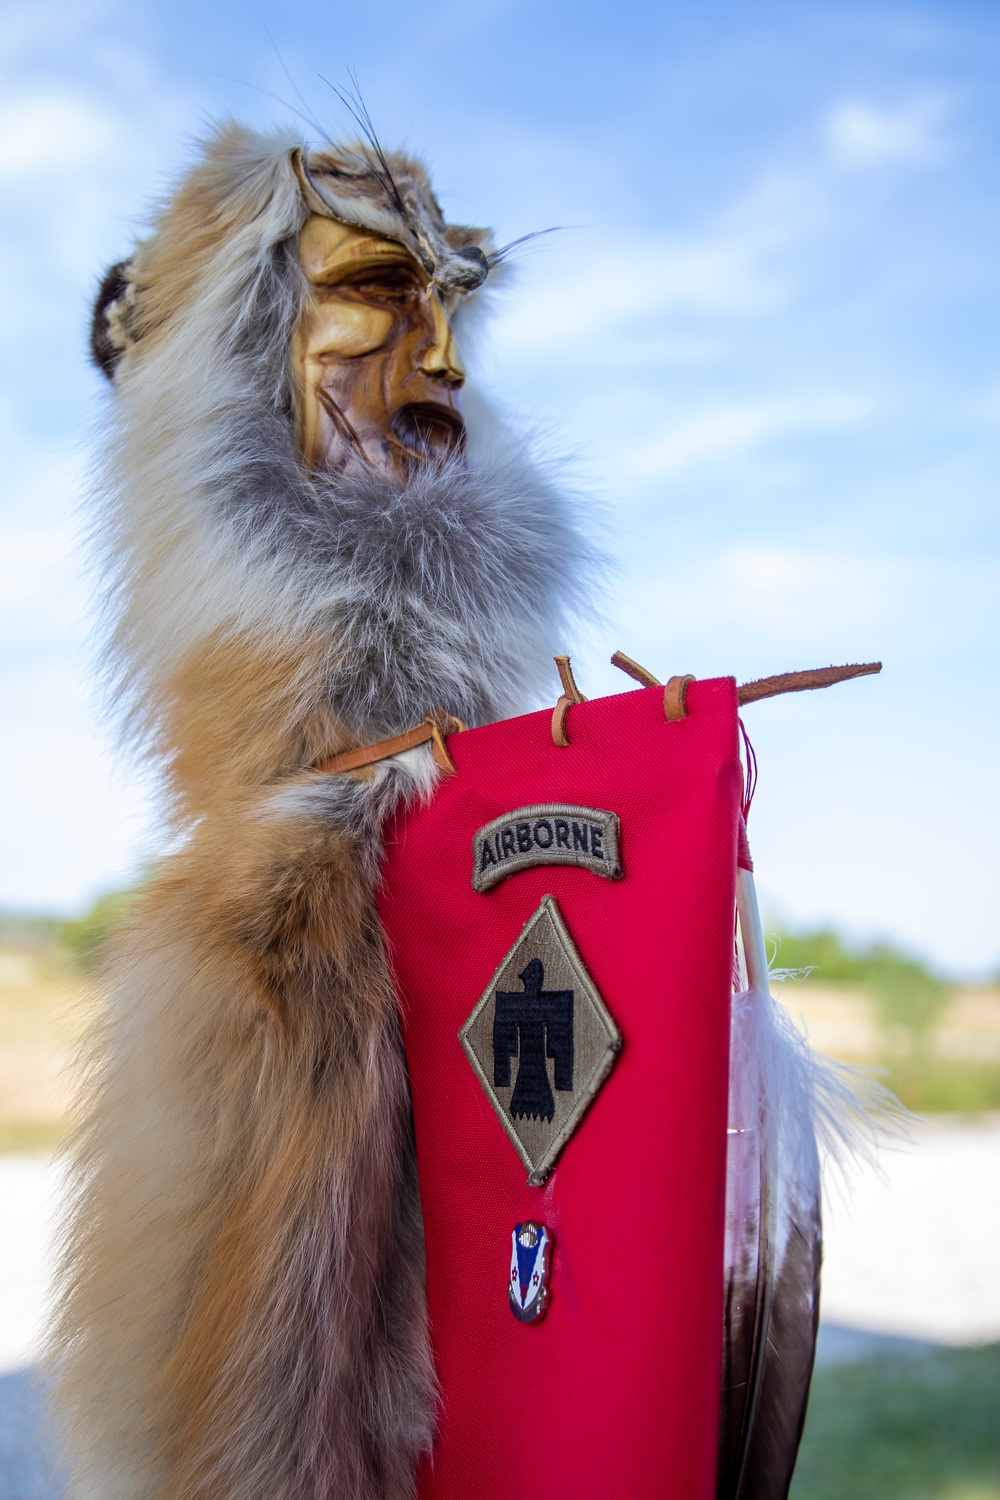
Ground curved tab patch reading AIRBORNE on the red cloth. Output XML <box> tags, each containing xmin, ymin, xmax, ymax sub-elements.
<box><xmin>472</xmin><ymin>803</ymin><xmax>622</xmax><ymax>891</ymax></box>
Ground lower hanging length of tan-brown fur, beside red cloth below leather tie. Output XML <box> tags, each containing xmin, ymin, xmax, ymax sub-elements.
<box><xmin>49</xmin><ymin>783</ymin><xmax>433</xmax><ymax>1500</ymax></box>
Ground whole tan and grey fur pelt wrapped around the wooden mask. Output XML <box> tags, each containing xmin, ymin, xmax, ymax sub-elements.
<box><xmin>55</xmin><ymin>128</ymin><xmax>588</xmax><ymax>1500</ymax></box>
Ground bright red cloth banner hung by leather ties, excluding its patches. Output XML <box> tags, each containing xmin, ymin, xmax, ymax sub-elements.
<box><xmin>379</xmin><ymin>678</ymin><xmax>741</xmax><ymax>1500</ymax></box>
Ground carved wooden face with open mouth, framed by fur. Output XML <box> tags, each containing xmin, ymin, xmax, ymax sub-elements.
<box><xmin>292</xmin><ymin>215</ymin><xmax>465</xmax><ymax>479</ymax></box>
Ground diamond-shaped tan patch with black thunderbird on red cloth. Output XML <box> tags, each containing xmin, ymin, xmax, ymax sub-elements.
<box><xmin>459</xmin><ymin>896</ymin><xmax>622</xmax><ymax>1187</ymax></box>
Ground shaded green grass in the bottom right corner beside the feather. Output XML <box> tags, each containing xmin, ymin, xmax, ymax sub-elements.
<box><xmin>792</xmin><ymin>1344</ymin><xmax>1000</xmax><ymax>1500</ymax></box>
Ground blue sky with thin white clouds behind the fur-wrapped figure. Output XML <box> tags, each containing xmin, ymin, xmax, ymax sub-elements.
<box><xmin>0</xmin><ymin>0</ymin><xmax>1000</xmax><ymax>975</ymax></box>
